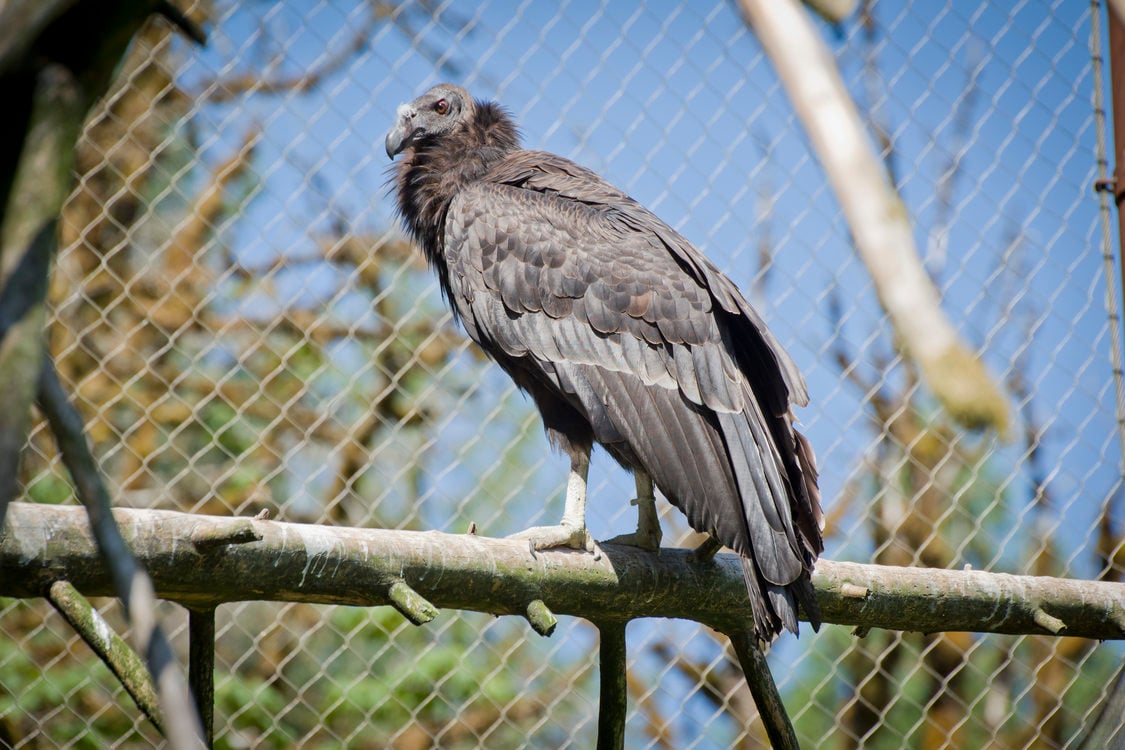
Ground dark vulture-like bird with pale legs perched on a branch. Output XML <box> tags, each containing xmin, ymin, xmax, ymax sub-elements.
<box><xmin>385</xmin><ymin>83</ymin><xmax>824</xmax><ymax>643</ymax></box>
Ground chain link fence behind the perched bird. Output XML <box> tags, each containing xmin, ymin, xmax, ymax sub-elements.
<box><xmin>0</xmin><ymin>0</ymin><xmax>1125</xmax><ymax>748</ymax></box>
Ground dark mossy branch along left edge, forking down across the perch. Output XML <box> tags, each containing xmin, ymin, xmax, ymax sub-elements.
<box><xmin>0</xmin><ymin>0</ymin><xmax>209</xmax><ymax>748</ymax></box>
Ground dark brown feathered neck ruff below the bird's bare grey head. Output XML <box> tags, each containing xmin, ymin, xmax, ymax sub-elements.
<box><xmin>395</xmin><ymin>100</ymin><xmax>520</xmax><ymax>265</ymax></box>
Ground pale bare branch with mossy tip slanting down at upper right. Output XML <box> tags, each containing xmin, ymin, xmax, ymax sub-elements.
<box><xmin>739</xmin><ymin>0</ymin><xmax>1008</xmax><ymax>433</ymax></box>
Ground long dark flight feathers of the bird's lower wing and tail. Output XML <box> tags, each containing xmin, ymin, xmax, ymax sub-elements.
<box><xmin>567</xmin><ymin>364</ymin><xmax>822</xmax><ymax>642</ymax></box>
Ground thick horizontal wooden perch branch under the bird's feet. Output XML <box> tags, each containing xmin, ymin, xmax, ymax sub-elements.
<box><xmin>0</xmin><ymin>503</ymin><xmax>1125</xmax><ymax>640</ymax></box>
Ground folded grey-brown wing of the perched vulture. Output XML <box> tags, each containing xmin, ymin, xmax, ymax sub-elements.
<box><xmin>446</xmin><ymin>152</ymin><xmax>820</xmax><ymax>634</ymax></box>
